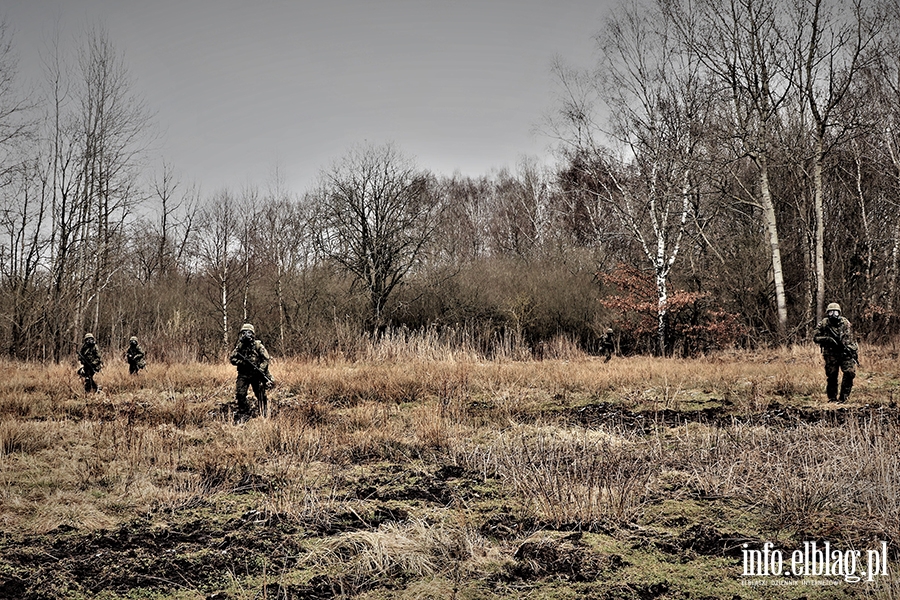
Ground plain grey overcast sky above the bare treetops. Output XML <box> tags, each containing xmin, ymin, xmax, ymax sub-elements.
<box><xmin>0</xmin><ymin>0</ymin><xmax>615</xmax><ymax>193</ymax></box>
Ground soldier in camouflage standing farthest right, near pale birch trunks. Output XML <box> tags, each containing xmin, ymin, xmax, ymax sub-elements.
<box><xmin>813</xmin><ymin>302</ymin><xmax>859</xmax><ymax>402</ymax></box>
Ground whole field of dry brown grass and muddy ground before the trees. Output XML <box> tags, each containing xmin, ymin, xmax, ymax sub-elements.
<box><xmin>0</xmin><ymin>342</ymin><xmax>900</xmax><ymax>600</ymax></box>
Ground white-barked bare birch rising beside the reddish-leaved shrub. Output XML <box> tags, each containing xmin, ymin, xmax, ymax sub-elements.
<box><xmin>557</xmin><ymin>0</ymin><xmax>709</xmax><ymax>354</ymax></box>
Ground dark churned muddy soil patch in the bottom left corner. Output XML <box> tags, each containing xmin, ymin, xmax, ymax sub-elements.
<box><xmin>0</xmin><ymin>519</ymin><xmax>301</xmax><ymax>600</ymax></box>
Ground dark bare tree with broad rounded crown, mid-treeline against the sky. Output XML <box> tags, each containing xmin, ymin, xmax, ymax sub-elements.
<box><xmin>314</xmin><ymin>144</ymin><xmax>441</xmax><ymax>331</ymax></box>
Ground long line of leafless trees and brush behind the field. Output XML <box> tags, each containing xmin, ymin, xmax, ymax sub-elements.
<box><xmin>0</xmin><ymin>0</ymin><xmax>900</xmax><ymax>360</ymax></box>
